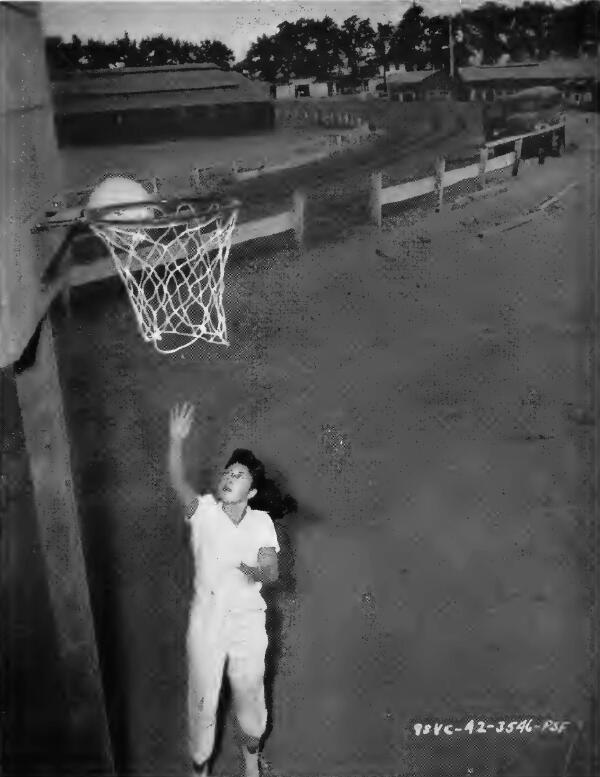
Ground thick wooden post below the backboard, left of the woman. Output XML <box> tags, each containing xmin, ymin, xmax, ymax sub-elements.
<box><xmin>15</xmin><ymin>317</ymin><xmax>115</xmax><ymax>775</ymax></box>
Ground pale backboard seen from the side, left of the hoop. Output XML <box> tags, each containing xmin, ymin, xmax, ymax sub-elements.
<box><xmin>0</xmin><ymin>2</ymin><xmax>62</xmax><ymax>367</ymax></box>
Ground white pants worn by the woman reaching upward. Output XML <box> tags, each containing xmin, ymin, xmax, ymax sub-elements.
<box><xmin>187</xmin><ymin>596</ymin><xmax>268</xmax><ymax>764</ymax></box>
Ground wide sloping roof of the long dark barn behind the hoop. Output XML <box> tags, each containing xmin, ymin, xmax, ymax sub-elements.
<box><xmin>52</xmin><ymin>64</ymin><xmax>269</xmax><ymax>113</ymax></box>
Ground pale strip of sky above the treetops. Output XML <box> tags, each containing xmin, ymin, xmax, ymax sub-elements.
<box><xmin>42</xmin><ymin>0</ymin><xmax>556</xmax><ymax>61</ymax></box>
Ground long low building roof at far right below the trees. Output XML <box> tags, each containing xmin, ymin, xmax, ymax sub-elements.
<box><xmin>458</xmin><ymin>58</ymin><xmax>600</xmax><ymax>83</ymax></box>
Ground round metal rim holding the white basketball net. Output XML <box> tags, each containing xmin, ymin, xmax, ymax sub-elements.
<box><xmin>83</xmin><ymin>197</ymin><xmax>241</xmax><ymax>229</ymax></box>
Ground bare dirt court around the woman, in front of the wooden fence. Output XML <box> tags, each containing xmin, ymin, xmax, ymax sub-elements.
<box><xmin>21</xmin><ymin>115</ymin><xmax>597</xmax><ymax>777</ymax></box>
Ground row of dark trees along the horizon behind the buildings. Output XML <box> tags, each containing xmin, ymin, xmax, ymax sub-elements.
<box><xmin>46</xmin><ymin>0</ymin><xmax>600</xmax><ymax>82</ymax></box>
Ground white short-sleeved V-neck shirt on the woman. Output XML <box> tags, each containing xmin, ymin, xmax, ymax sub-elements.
<box><xmin>187</xmin><ymin>494</ymin><xmax>279</xmax><ymax>610</ymax></box>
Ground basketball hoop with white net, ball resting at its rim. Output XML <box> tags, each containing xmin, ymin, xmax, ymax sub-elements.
<box><xmin>84</xmin><ymin>198</ymin><xmax>240</xmax><ymax>353</ymax></box>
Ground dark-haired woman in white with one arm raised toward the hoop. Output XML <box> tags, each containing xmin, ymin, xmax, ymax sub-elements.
<box><xmin>169</xmin><ymin>404</ymin><xmax>279</xmax><ymax>777</ymax></box>
